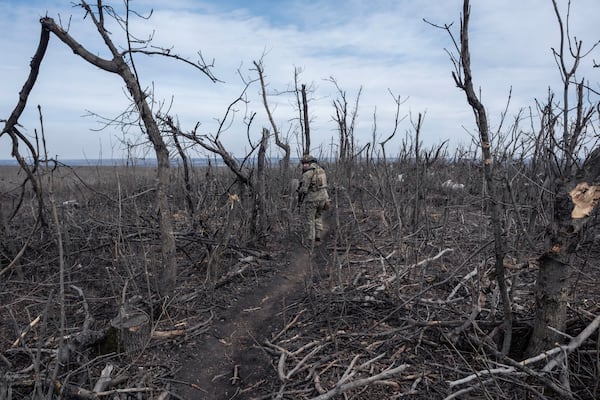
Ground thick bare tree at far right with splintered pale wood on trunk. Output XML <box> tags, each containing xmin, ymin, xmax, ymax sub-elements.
<box><xmin>527</xmin><ymin>0</ymin><xmax>600</xmax><ymax>355</ymax></box>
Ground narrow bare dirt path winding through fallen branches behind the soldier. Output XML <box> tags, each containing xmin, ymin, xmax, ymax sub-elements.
<box><xmin>173</xmin><ymin>238</ymin><xmax>326</xmax><ymax>400</ymax></box>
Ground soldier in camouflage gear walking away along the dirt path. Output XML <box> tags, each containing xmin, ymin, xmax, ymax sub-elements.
<box><xmin>298</xmin><ymin>154</ymin><xmax>329</xmax><ymax>244</ymax></box>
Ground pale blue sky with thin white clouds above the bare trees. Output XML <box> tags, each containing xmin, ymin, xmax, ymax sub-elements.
<box><xmin>0</xmin><ymin>0</ymin><xmax>600</xmax><ymax>160</ymax></box>
